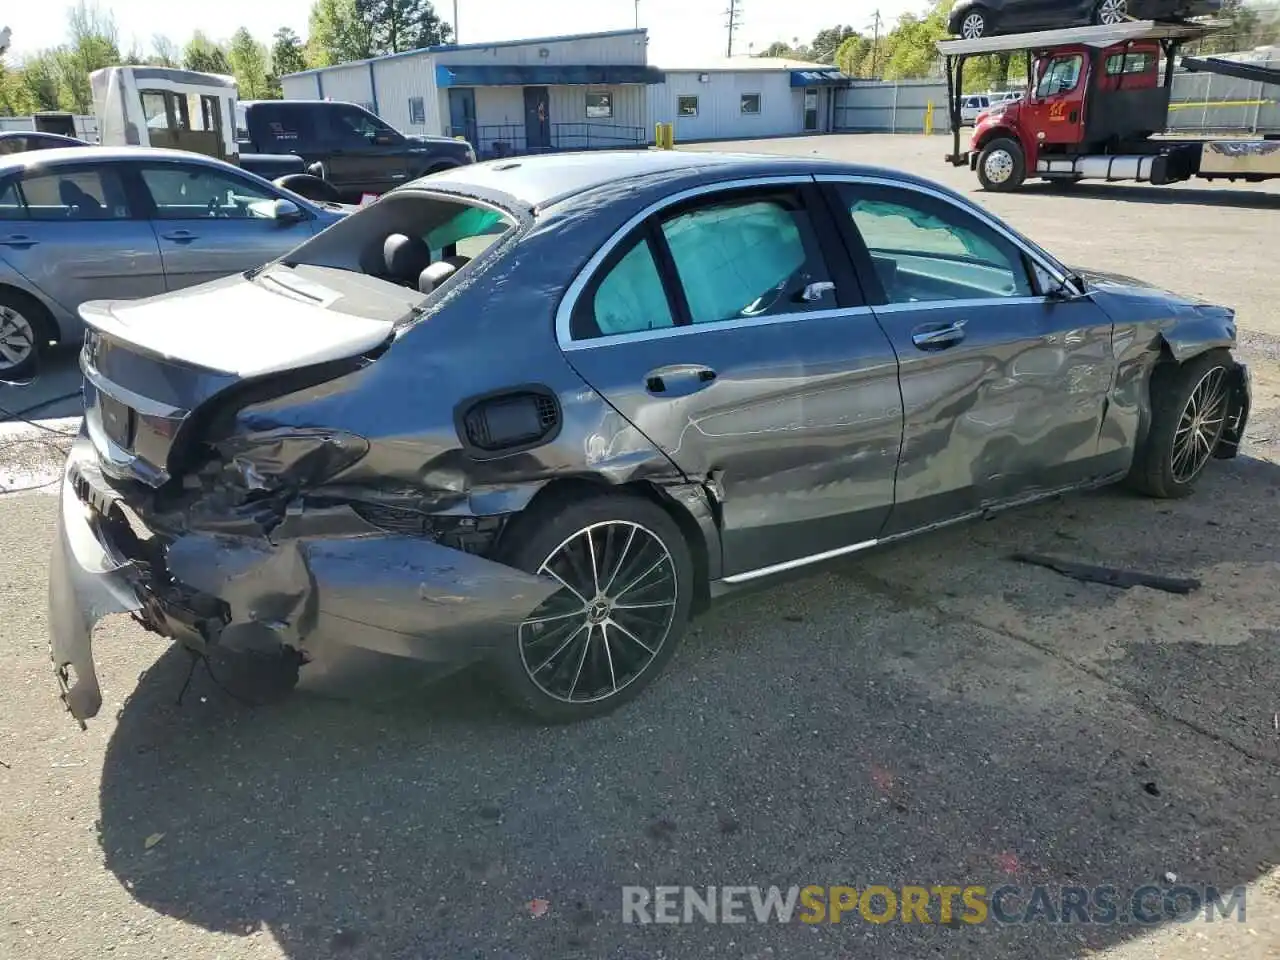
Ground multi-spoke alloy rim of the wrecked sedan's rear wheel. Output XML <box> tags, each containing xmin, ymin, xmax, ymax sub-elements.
<box><xmin>518</xmin><ymin>521</ymin><xmax>678</xmax><ymax>703</ymax></box>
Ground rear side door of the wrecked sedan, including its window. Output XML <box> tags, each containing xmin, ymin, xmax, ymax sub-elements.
<box><xmin>557</xmin><ymin>178</ymin><xmax>902</xmax><ymax>581</ymax></box>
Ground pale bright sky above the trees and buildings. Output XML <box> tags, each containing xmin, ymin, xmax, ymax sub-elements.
<box><xmin>0</xmin><ymin>0</ymin><xmax>927</xmax><ymax>64</ymax></box>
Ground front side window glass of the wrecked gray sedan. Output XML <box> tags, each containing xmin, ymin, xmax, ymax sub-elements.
<box><xmin>842</xmin><ymin>187</ymin><xmax>1033</xmax><ymax>303</ymax></box>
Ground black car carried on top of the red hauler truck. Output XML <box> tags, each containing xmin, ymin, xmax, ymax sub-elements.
<box><xmin>947</xmin><ymin>0</ymin><xmax>1222</xmax><ymax>40</ymax></box>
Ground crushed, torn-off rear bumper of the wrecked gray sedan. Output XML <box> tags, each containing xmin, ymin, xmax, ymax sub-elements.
<box><xmin>49</xmin><ymin>434</ymin><xmax>558</xmax><ymax>726</ymax></box>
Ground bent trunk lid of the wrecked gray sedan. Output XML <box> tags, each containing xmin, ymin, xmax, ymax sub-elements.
<box><xmin>81</xmin><ymin>269</ymin><xmax>399</xmax><ymax>486</ymax></box>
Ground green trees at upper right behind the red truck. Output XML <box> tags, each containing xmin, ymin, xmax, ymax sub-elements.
<box><xmin>759</xmin><ymin>0</ymin><xmax>1280</xmax><ymax>91</ymax></box>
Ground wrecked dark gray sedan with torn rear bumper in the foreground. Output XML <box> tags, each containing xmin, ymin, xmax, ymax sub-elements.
<box><xmin>50</xmin><ymin>152</ymin><xmax>1249</xmax><ymax>722</ymax></box>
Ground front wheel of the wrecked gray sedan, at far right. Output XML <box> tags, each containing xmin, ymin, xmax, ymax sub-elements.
<box><xmin>1129</xmin><ymin>349</ymin><xmax>1234</xmax><ymax>499</ymax></box>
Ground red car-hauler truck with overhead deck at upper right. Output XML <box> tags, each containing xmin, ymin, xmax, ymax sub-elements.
<box><xmin>938</xmin><ymin>20</ymin><xmax>1280</xmax><ymax>191</ymax></box>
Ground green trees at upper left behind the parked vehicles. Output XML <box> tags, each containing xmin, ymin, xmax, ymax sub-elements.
<box><xmin>0</xmin><ymin>0</ymin><xmax>453</xmax><ymax>116</ymax></box>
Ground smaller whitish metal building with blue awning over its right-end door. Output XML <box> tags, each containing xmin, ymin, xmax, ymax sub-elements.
<box><xmin>649</xmin><ymin>56</ymin><xmax>849</xmax><ymax>143</ymax></box>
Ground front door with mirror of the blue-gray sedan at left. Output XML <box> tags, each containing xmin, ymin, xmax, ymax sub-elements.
<box><xmin>132</xmin><ymin>161</ymin><xmax>314</xmax><ymax>291</ymax></box>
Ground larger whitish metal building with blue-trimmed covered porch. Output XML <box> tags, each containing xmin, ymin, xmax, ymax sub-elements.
<box><xmin>282</xmin><ymin>29</ymin><xmax>662</xmax><ymax>155</ymax></box>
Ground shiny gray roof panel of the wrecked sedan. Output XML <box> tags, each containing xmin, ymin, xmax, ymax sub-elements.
<box><xmin>404</xmin><ymin>150</ymin><xmax>933</xmax><ymax>210</ymax></box>
